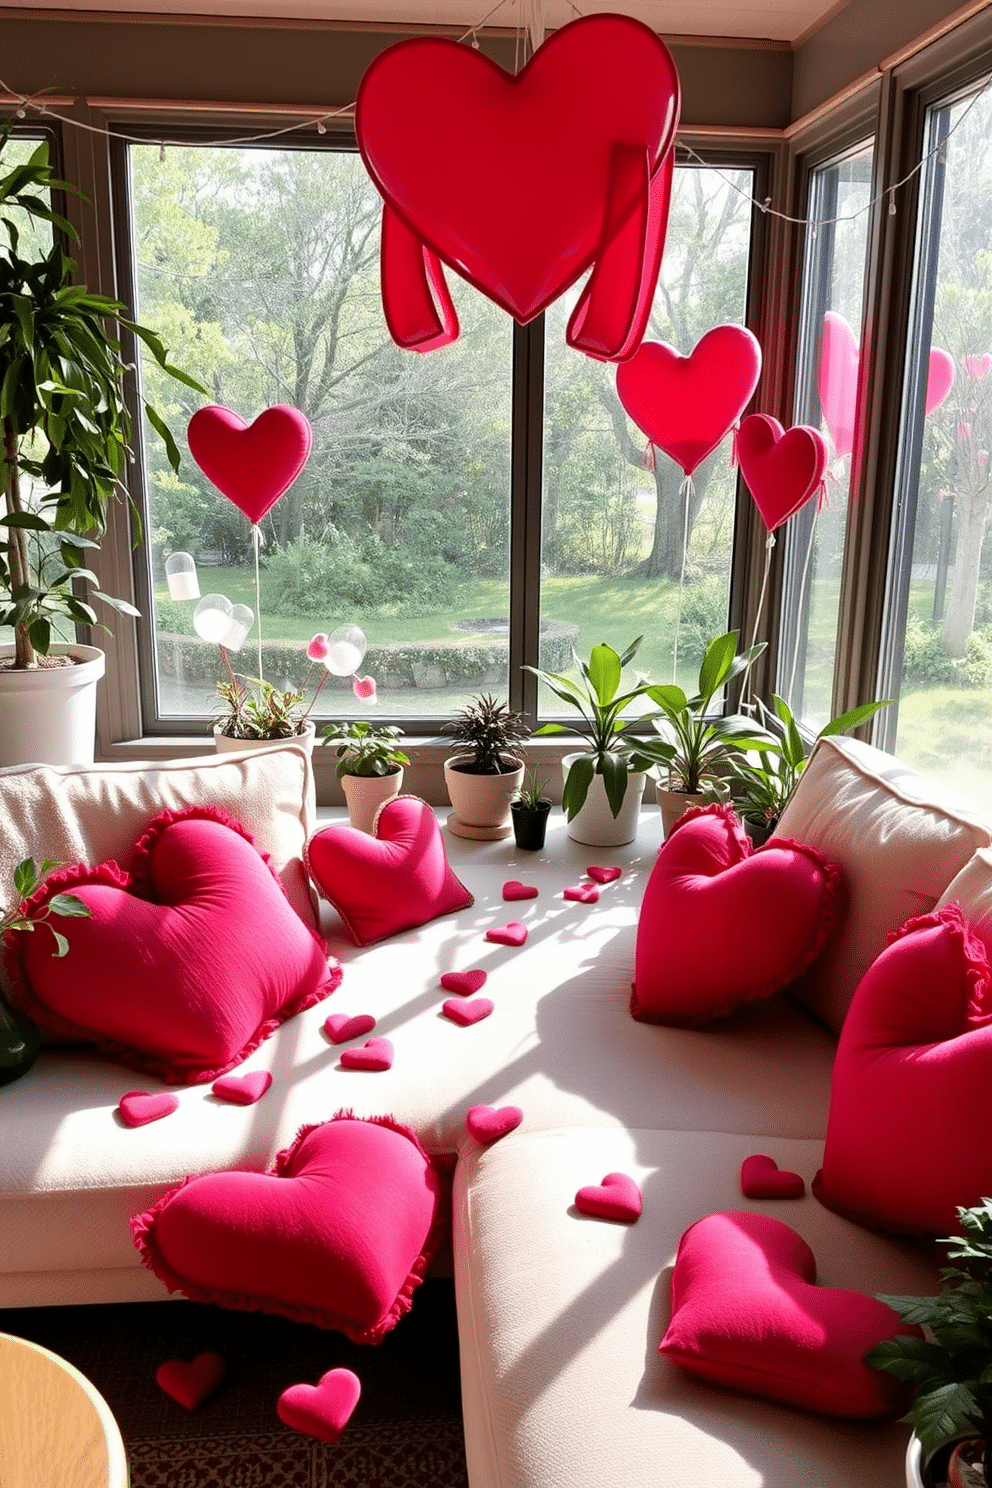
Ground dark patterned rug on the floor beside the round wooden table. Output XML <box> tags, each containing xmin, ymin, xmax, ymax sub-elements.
<box><xmin>0</xmin><ymin>1280</ymin><xmax>468</xmax><ymax>1488</ymax></box>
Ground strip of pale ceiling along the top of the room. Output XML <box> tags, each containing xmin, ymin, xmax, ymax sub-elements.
<box><xmin>3</xmin><ymin>0</ymin><xmax>849</xmax><ymax>46</ymax></box>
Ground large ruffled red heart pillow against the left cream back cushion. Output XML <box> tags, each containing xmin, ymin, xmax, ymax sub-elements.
<box><xmin>7</xmin><ymin>806</ymin><xmax>341</xmax><ymax>1085</ymax></box>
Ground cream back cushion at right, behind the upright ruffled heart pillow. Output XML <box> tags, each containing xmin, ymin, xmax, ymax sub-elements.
<box><xmin>775</xmin><ymin>738</ymin><xmax>992</xmax><ymax>1033</ymax></box>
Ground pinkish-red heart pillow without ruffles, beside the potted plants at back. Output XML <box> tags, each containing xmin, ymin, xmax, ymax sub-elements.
<box><xmin>305</xmin><ymin>796</ymin><xmax>473</xmax><ymax>945</ymax></box>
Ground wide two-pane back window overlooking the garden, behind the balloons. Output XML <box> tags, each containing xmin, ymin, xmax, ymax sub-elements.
<box><xmin>126</xmin><ymin>140</ymin><xmax>754</xmax><ymax>732</ymax></box>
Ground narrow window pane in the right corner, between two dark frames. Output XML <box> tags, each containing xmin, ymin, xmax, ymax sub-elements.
<box><xmin>778</xmin><ymin>143</ymin><xmax>875</xmax><ymax>731</ymax></box>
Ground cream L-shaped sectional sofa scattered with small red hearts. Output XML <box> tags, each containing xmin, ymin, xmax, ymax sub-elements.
<box><xmin>0</xmin><ymin>740</ymin><xmax>992</xmax><ymax>1488</ymax></box>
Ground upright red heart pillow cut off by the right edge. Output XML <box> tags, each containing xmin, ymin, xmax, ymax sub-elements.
<box><xmin>812</xmin><ymin>905</ymin><xmax>992</xmax><ymax>1235</ymax></box>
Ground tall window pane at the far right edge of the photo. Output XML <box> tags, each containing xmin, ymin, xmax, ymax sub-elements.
<box><xmin>883</xmin><ymin>75</ymin><xmax>992</xmax><ymax>805</ymax></box>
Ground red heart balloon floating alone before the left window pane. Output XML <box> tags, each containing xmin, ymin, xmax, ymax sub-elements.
<box><xmin>186</xmin><ymin>403</ymin><xmax>312</xmax><ymax>522</ymax></box>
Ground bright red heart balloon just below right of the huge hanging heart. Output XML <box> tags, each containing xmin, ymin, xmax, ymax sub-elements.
<box><xmin>617</xmin><ymin>326</ymin><xmax>761</xmax><ymax>475</ymax></box>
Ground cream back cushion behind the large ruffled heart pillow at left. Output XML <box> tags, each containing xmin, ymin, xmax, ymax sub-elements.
<box><xmin>0</xmin><ymin>744</ymin><xmax>317</xmax><ymax>999</ymax></box>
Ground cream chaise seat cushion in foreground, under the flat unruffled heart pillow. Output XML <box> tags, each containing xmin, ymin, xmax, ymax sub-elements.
<box><xmin>454</xmin><ymin>1128</ymin><xmax>935</xmax><ymax>1488</ymax></box>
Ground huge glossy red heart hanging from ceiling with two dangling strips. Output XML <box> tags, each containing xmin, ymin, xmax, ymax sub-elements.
<box><xmin>355</xmin><ymin>15</ymin><xmax>680</xmax><ymax>356</ymax></box>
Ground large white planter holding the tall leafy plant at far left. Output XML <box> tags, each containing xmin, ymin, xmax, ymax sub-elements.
<box><xmin>0</xmin><ymin>644</ymin><xmax>107</xmax><ymax>765</ymax></box>
